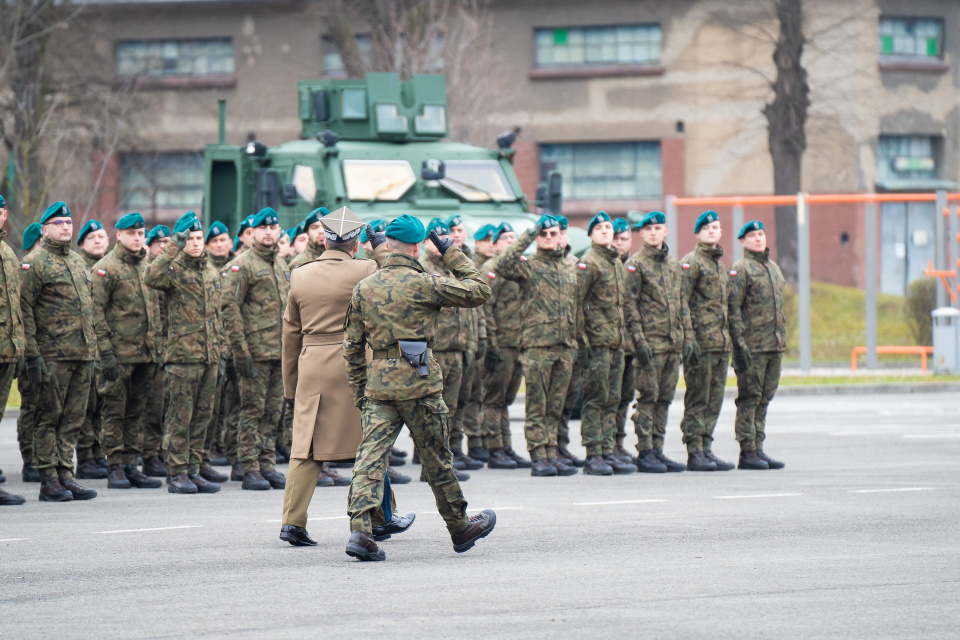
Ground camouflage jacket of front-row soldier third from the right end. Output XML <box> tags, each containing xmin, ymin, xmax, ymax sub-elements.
<box><xmin>627</xmin><ymin>244</ymin><xmax>693</xmax><ymax>353</ymax></box>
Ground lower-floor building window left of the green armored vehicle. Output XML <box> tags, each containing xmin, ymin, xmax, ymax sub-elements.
<box><xmin>121</xmin><ymin>151</ymin><xmax>203</xmax><ymax>211</ymax></box>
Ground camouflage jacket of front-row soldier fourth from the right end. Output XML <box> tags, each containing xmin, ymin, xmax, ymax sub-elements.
<box><xmin>577</xmin><ymin>243</ymin><xmax>636</xmax><ymax>349</ymax></box>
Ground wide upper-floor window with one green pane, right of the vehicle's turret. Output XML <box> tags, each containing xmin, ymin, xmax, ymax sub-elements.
<box><xmin>536</xmin><ymin>24</ymin><xmax>661</xmax><ymax>68</ymax></box>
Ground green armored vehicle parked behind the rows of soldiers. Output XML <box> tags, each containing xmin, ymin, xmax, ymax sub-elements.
<box><xmin>203</xmin><ymin>73</ymin><xmax>588</xmax><ymax>250</ymax></box>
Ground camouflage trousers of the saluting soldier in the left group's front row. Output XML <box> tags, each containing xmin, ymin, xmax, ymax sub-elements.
<box><xmin>163</xmin><ymin>364</ymin><xmax>217</xmax><ymax>476</ymax></box>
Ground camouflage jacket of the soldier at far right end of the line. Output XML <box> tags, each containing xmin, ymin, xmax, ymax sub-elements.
<box><xmin>730</xmin><ymin>249</ymin><xmax>787</xmax><ymax>353</ymax></box>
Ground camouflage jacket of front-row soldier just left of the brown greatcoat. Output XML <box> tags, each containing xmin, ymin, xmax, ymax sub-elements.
<box><xmin>223</xmin><ymin>242</ymin><xmax>290</xmax><ymax>360</ymax></box>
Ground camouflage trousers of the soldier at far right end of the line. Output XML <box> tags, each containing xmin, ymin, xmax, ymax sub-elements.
<box><xmin>734</xmin><ymin>351</ymin><xmax>783</xmax><ymax>451</ymax></box>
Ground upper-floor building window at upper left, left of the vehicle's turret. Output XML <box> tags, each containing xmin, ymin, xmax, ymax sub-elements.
<box><xmin>117</xmin><ymin>38</ymin><xmax>233</xmax><ymax>76</ymax></box>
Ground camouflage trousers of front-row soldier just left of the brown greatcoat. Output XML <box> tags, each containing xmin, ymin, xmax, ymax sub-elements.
<box><xmin>237</xmin><ymin>360</ymin><xmax>283</xmax><ymax>473</ymax></box>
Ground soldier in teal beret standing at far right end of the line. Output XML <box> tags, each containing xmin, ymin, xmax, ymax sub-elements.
<box><xmin>730</xmin><ymin>220</ymin><xmax>787</xmax><ymax>469</ymax></box>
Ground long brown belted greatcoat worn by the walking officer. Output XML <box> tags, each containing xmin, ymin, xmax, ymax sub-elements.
<box><xmin>283</xmin><ymin>243</ymin><xmax>386</xmax><ymax>461</ymax></box>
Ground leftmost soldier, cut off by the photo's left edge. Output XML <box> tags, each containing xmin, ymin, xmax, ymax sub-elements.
<box><xmin>0</xmin><ymin>196</ymin><xmax>27</xmax><ymax>506</ymax></box>
